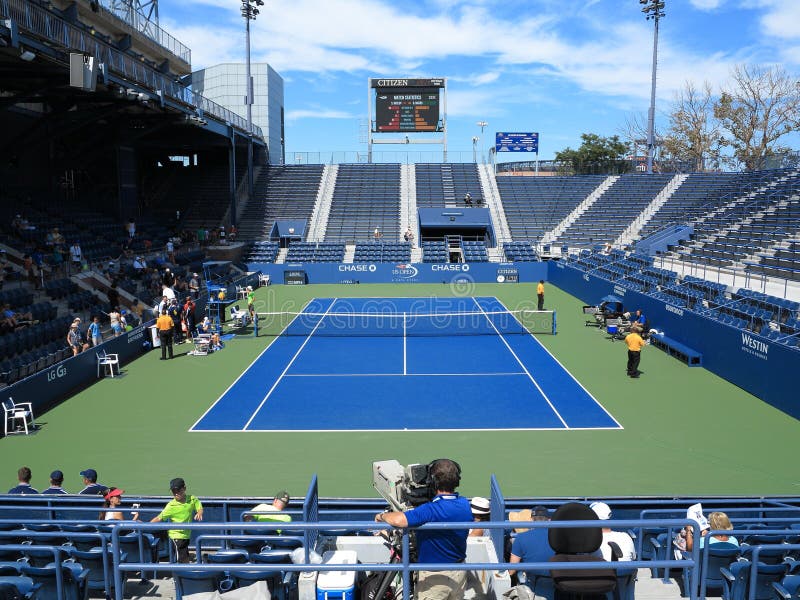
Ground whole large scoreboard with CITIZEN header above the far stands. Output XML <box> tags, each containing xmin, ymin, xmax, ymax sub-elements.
<box><xmin>370</xmin><ymin>79</ymin><xmax>444</xmax><ymax>133</ymax></box>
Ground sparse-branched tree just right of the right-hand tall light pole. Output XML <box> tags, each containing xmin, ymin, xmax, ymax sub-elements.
<box><xmin>664</xmin><ymin>81</ymin><xmax>720</xmax><ymax>171</ymax></box>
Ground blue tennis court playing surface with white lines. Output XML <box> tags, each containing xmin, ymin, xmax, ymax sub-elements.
<box><xmin>191</xmin><ymin>297</ymin><xmax>621</xmax><ymax>432</ymax></box>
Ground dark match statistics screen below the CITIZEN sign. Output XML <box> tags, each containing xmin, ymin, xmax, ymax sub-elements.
<box><xmin>375</xmin><ymin>88</ymin><xmax>439</xmax><ymax>133</ymax></box>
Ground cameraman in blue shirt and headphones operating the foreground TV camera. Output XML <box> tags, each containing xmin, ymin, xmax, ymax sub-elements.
<box><xmin>375</xmin><ymin>458</ymin><xmax>472</xmax><ymax>600</ymax></box>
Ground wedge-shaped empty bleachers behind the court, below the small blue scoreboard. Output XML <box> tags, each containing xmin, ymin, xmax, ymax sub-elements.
<box><xmin>497</xmin><ymin>175</ymin><xmax>605</xmax><ymax>242</ymax></box>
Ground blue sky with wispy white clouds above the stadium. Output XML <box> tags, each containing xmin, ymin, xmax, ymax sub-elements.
<box><xmin>159</xmin><ymin>0</ymin><xmax>800</xmax><ymax>162</ymax></box>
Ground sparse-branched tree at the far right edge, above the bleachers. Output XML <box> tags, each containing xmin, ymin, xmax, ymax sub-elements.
<box><xmin>714</xmin><ymin>65</ymin><xmax>800</xmax><ymax>169</ymax></box>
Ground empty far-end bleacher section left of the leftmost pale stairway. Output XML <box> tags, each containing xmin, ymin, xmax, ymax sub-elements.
<box><xmin>239</xmin><ymin>165</ymin><xmax>325</xmax><ymax>240</ymax></box>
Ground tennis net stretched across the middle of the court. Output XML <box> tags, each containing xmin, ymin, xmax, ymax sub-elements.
<box><xmin>258</xmin><ymin>310</ymin><xmax>556</xmax><ymax>337</ymax></box>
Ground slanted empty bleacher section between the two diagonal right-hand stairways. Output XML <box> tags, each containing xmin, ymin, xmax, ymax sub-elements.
<box><xmin>554</xmin><ymin>174</ymin><xmax>672</xmax><ymax>247</ymax></box>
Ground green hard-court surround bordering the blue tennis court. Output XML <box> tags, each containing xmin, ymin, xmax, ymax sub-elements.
<box><xmin>0</xmin><ymin>284</ymin><xmax>800</xmax><ymax>497</ymax></box>
